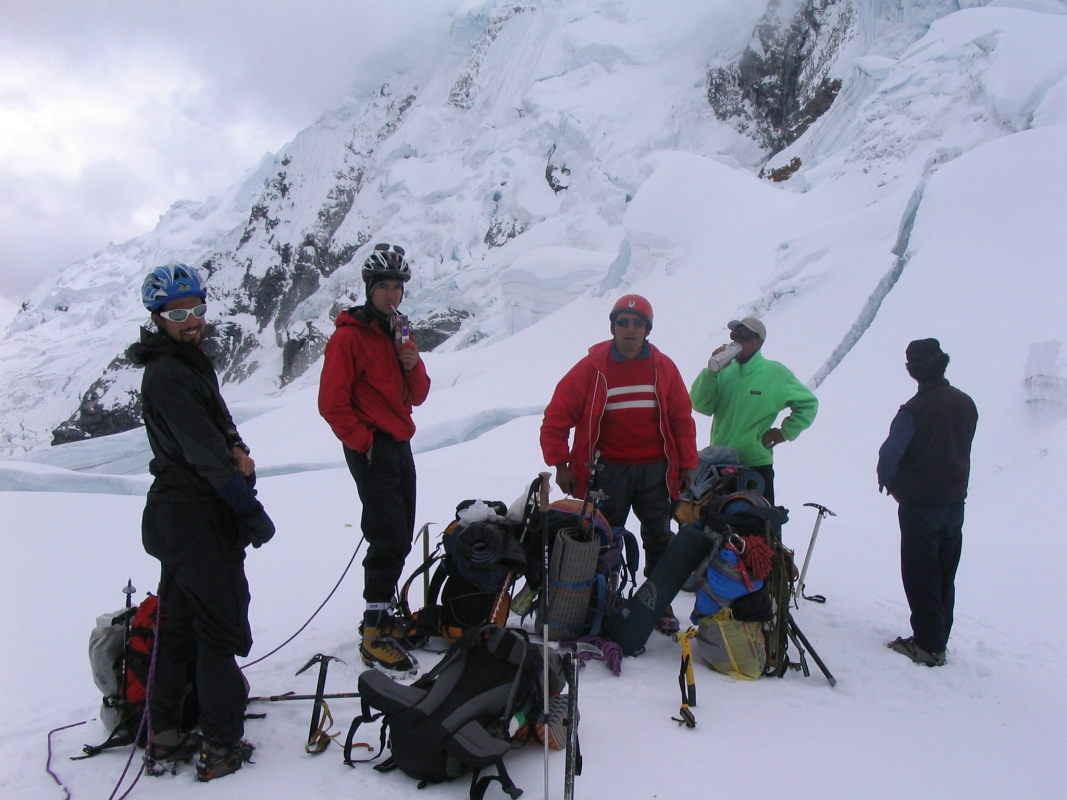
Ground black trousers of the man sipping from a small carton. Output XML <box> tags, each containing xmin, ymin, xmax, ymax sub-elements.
<box><xmin>345</xmin><ymin>431</ymin><xmax>415</xmax><ymax>603</ymax></box>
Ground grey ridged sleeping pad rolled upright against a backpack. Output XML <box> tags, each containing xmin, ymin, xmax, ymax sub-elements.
<box><xmin>537</xmin><ymin>528</ymin><xmax>600</xmax><ymax>641</ymax></box>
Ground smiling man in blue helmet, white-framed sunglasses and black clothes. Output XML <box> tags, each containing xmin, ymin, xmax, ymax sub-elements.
<box><xmin>129</xmin><ymin>263</ymin><xmax>274</xmax><ymax>781</ymax></box>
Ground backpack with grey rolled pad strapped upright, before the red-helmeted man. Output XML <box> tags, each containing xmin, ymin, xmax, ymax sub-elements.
<box><xmin>526</xmin><ymin>498</ymin><xmax>640</xmax><ymax>641</ymax></box>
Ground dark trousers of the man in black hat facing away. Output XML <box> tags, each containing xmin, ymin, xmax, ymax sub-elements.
<box><xmin>897</xmin><ymin>500</ymin><xmax>964</xmax><ymax>653</ymax></box>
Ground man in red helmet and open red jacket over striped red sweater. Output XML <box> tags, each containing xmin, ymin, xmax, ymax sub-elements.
<box><xmin>541</xmin><ymin>294</ymin><xmax>697</xmax><ymax>633</ymax></box>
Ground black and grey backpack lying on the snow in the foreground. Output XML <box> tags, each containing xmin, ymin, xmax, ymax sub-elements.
<box><xmin>345</xmin><ymin>625</ymin><xmax>566</xmax><ymax>800</ymax></box>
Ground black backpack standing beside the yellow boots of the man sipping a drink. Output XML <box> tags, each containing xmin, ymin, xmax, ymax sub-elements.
<box><xmin>400</xmin><ymin>500</ymin><xmax>527</xmax><ymax>644</ymax></box>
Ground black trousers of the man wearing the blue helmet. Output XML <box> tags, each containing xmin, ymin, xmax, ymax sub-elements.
<box><xmin>141</xmin><ymin>499</ymin><xmax>252</xmax><ymax>747</ymax></box>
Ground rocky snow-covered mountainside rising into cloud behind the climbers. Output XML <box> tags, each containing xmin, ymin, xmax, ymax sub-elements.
<box><xmin>0</xmin><ymin>0</ymin><xmax>981</xmax><ymax>453</ymax></box>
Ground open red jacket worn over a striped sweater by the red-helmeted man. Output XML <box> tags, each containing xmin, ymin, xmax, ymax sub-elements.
<box><xmin>541</xmin><ymin>340</ymin><xmax>697</xmax><ymax>499</ymax></box>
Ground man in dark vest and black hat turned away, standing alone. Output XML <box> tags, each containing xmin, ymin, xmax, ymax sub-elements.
<box><xmin>878</xmin><ymin>339</ymin><xmax>978</xmax><ymax>667</ymax></box>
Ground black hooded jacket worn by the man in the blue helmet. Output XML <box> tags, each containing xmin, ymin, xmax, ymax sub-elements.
<box><xmin>127</xmin><ymin>329</ymin><xmax>243</xmax><ymax>501</ymax></box>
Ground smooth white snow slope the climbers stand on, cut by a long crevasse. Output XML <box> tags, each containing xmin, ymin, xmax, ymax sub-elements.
<box><xmin>0</xmin><ymin>3</ymin><xmax>1067</xmax><ymax>798</ymax></box>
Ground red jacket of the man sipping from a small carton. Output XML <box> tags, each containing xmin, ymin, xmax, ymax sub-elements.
<box><xmin>319</xmin><ymin>311</ymin><xmax>430</xmax><ymax>452</ymax></box>
